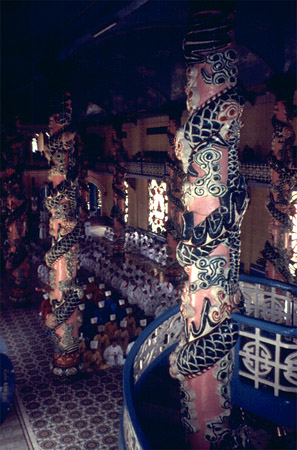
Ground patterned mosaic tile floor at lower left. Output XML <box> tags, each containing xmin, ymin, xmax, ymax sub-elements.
<box><xmin>0</xmin><ymin>305</ymin><xmax>123</xmax><ymax>450</ymax></box>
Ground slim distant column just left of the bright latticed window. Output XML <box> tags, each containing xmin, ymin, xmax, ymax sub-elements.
<box><xmin>110</xmin><ymin>126</ymin><xmax>126</xmax><ymax>256</ymax></box>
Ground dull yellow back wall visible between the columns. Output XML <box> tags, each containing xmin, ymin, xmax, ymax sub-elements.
<box><xmin>1</xmin><ymin>94</ymin><xmax>297</xmax><ymax>273</ymax></box>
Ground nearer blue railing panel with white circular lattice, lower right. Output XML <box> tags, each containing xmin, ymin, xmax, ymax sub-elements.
<box><xmin>230</xmin><ymin>313</ymin><xmax>297</xmax><ymax>428</ymax></box>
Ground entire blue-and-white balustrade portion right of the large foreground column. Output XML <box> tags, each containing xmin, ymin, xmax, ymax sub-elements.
<box><xmin>230</xmin><ymin>275</ymin><xmax>297</xmax><ymax>428</ymax></box>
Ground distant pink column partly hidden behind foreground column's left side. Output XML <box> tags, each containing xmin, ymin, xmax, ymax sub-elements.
<box><xmin>166</xmin><ymin>112</ymin><xmax>185</xmax><ymax>281</ymax></box>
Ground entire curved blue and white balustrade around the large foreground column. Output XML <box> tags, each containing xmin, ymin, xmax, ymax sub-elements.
<box><xmin>119</xmin><ymin>275</ymin><xmax>297</xmax><ymax>450</ymax></box>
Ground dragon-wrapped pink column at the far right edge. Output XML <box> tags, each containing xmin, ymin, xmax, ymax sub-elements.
<box><xmin>262</xmin><ymin>76</ymin><xmax>297</xmax><ymax>284</ymax></box>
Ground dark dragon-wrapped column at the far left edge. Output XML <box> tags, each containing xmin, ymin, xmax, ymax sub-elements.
<box><xmin>3</xmin><ymin>118</ymin><xmax>29</xmax><ymax>304</ymax></box>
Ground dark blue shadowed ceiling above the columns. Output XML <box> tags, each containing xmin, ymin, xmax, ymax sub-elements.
<box><xmin>0</xmin><ymin>0</ymin><xmax>296</xmax><ymax>126</ymax></box>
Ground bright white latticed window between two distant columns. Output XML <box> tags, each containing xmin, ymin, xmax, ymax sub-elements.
<box><xmin>149</xmin><ymin>180</ymin><xmax>168</xmax><ymax>234</ymax></box>
